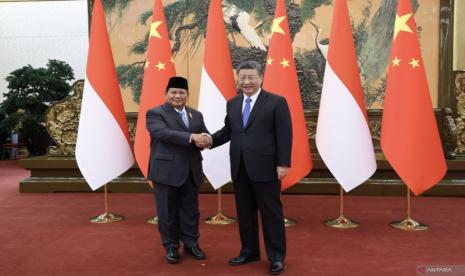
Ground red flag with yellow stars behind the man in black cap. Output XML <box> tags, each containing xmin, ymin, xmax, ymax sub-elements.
<box><xmin>134</xmin><ymin>0</ymin><xmax>176</xmax><ymax>177</ymax></box>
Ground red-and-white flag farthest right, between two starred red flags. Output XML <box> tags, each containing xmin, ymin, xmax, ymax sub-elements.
<box><xmin>316</xmin><ymin>0</ymin><xmax>376</xmax><ymax>192</ymax></box>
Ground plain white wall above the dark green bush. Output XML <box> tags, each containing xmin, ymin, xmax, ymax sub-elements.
<box><xmin>0</xmin><ymin>0</ymin><xmax>88</xmax><ymax>102</ymax></box>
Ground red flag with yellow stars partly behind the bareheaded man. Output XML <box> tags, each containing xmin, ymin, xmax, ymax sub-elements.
<box><xmin>263</xmin><ymin>0</ymin><xmax>313</xmax><ymax>191</ymax></box>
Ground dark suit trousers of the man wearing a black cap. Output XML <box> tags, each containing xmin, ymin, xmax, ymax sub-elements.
<box><xmin>154</xmin><ymin>172</ymin><xmax>200</xmax><ymax>249</ymax></box>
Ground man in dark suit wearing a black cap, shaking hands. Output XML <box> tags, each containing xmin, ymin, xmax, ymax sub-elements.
<box><xmin>147</xmin><ymin>77</ymin><xmax>208</xmax><ymax>263</ymax></box>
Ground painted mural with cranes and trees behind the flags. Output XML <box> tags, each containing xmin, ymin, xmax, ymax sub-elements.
<box><xmin>105</xmin><ymin>0</ymin><xmax>439</xmax><ymax>112</ymax></box>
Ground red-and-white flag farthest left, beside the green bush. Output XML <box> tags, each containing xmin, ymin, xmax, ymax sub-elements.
<box><xmin>76</xmin><ymin>0</ymin><xmax>134</xmax><ymax>190</ymax></box>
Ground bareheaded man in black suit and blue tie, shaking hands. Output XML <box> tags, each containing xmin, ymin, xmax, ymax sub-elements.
<box><xmin>212</xmin><ymin>61</ymin><xmax>292</xmax><ymax>274</ymax></box>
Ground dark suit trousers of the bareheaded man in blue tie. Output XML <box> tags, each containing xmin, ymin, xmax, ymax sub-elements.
<box><xmin>234</xmin><ymin>160</ymin><xmax>286</xmax><ymax>262</ymax></box>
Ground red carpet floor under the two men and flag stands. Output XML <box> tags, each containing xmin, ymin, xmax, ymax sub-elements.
<box><xmin>0</xmin><ymin>158</ymin><xmax>465</xmax><ymax>275</ymax></box>
